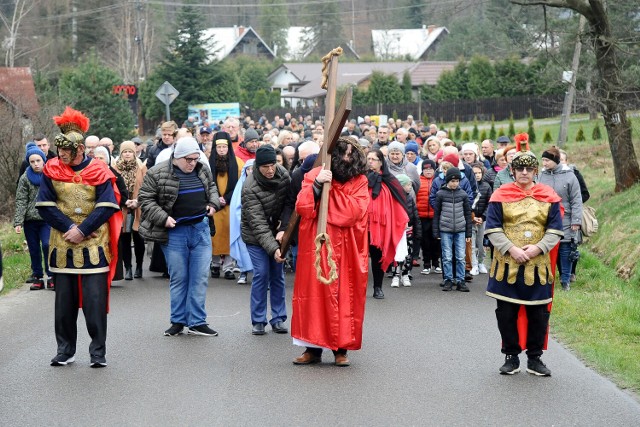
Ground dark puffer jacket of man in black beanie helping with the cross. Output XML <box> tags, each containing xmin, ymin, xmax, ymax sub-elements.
<box><xmin>240</xmin><ymin>165</ymin><xmax>291</xmax><ymax>257</ymax></box>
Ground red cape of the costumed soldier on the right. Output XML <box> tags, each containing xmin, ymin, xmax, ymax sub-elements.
<box><xmin>490</xmin><ymin>182</ymin><xmax>564</xmax><ymax>350</ymax></box>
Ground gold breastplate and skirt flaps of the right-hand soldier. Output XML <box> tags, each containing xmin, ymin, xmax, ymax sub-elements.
<box><xmin>491</xmin><ymin>197</ymin><xmax>553</xmax><ymax>286</ymax></box>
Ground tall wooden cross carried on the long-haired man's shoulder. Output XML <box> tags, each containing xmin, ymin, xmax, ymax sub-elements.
<box><xmin>280</xmin><ymin>48</ymin><xmax>353</xmax><ymax>257</ymax></box>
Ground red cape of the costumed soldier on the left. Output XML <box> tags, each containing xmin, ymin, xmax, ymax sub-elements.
<box><xmin>43</xmin><ymin>157</ymin><xmax>122</xmax><ymax>312</ymax></box>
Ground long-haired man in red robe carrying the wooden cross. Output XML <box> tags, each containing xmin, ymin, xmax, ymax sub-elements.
<box><xmin>291</xmin><ymin>137</ymin><xmax>369</xmax><ymax>366</ymax></box>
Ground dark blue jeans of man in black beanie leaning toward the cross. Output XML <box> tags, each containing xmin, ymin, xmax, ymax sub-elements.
<box><xmin>247</xmin><ymin>245</ymin><xmax>287</xmax><ymax>325</ymax></box>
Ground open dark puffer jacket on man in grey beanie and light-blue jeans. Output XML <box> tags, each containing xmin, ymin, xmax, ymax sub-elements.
<box><xmin>138</xmin><ymin>160</ymin><xmax>220</xmax><ymax>243</ymax></box>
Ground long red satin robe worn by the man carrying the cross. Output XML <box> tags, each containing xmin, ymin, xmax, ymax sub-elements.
<box><xmin>291</xmin><ymin>167</ymin><xmax>369</xmax><ymax>350</ymax></box>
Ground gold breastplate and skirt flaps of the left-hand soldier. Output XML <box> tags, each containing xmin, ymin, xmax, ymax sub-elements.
<box><xmin>50</xmin><ymin>181</ymin><xmax>111</xmax><ymax>268</ymax></box>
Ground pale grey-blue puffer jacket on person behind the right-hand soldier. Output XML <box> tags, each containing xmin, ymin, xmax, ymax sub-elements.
<box><xmin>538</xmin><ymin>164</ymin><xmax>582</xmax><ymax>242</ymax></box>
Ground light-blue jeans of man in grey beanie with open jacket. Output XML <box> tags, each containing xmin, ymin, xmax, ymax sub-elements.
<box><xmin>161</xmin><ymin>218</ymin><xmax>211</xmax><ymax>327</ymax></box>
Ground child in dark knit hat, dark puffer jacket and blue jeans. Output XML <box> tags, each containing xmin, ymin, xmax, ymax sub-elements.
<box><xmin>433</xmin><ymin>167</ymin><xmax>471</xmax><ymax>292</ymax></box>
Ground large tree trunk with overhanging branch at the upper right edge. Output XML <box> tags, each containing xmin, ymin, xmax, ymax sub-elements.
<box><xmin>510</xmin><ymin>0</ymin><xmax>640</xmax><ymax>192</ymax></box>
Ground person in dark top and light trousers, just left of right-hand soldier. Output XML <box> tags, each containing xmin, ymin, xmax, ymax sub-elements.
<box><xmin>471</xmin><ymin>162</ymin><xmax>493</xmax><ymax>276</ymax></box>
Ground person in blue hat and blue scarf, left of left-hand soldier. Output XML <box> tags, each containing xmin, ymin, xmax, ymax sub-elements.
<box><xmin>13</xmin><ymin>144</ymin><xmax>54</xmax><ymax>291</ymax></box>
